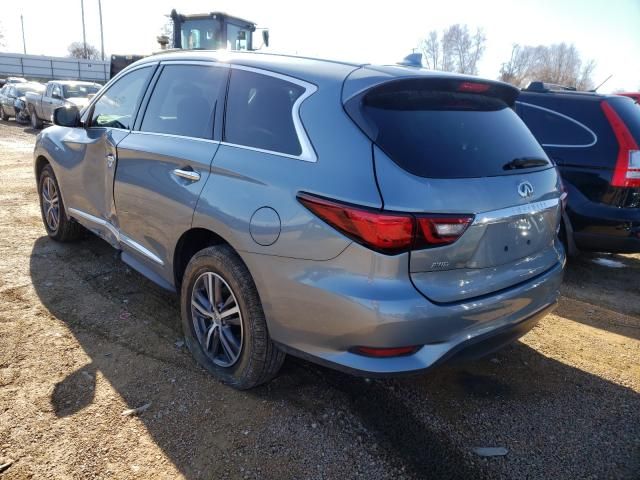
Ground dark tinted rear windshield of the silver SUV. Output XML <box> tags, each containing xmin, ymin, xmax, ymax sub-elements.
<box><xmin>362</xmin><ymin>82</ymin><xmax>551</xmax><ymax>178</ymax></box>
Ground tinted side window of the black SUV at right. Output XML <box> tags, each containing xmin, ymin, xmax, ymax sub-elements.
<box><xmin>521</xmin><ymin>104</ymin><xmax>595</xmax><ymax>147</ymax></box>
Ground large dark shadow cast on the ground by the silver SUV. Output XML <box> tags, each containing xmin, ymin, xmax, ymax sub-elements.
<box><xmin>30</xmin><ymin>237</ymin><xmax>640</xmax><ymax>479</ymax></box>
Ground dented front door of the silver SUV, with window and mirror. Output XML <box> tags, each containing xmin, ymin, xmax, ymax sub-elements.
<box><xmin>64</xmin><ymin>66</ymin><xmax>153</xmax><ymax>246</ymax></box>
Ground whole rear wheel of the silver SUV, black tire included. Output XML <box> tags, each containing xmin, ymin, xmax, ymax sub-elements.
<box><xmin>180</xmin><ymin>245</ymin><xmax>285</xmax><ymax>390</ymax></box>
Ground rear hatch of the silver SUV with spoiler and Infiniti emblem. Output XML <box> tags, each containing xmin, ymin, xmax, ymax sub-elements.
<box><xmin>345</xmin><ymin>76</ymin><xmax>562</xmax><ymax>303</ymax></box>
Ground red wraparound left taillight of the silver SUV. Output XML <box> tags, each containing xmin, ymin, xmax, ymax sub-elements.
<box><xmin>298</xmin><ymin>193</ymin><xmax>473</xmax><ymax>255</ymax></box>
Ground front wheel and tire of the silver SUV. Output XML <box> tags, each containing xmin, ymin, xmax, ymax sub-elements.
<box><xmin>38</xmin><ymin>165</ymin><xmax>84</xmax><ymax>242</ymax></box>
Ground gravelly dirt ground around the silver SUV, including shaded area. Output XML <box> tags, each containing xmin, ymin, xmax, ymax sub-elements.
<box><xmin>0</xmin><ymin>117</ymin><xmax>640</xmax><ymax>479</ymax></box>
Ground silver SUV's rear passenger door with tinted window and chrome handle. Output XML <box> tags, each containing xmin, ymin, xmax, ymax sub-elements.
<box><xmin>114</xmin><ymin>62</ymin><xmax>228</xmax><ymax>282</ymax></box>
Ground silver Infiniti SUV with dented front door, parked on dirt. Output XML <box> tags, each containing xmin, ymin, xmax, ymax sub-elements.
<box><xmin>34</xmin><ymin>51</ymin><xmax>565</xmax><ymax>388</ymax></box>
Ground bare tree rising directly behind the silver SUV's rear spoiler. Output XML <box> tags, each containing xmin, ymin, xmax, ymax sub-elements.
<box><xmin>419</xmin><ymin>24</ymin><xmax>487</xmax><ymax>75</ymax></box>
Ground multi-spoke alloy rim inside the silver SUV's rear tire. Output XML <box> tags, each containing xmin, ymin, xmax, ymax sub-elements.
<box><xmin>191</xmin><ymin>272</ymin><xmax>243</xmax><ymax>368</ymax></box>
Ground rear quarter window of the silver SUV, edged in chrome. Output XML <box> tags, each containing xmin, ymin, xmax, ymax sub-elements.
<box><xmin>224</xmin><ymin>69</ymin><xmax>304</xmax><ymax>155</ymax></box>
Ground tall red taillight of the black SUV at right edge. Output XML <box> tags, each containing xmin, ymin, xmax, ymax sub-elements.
<box><xmin>600</xmin><ymin>101</ymin><xmax>640</xmax><ymax>187</ymax></box>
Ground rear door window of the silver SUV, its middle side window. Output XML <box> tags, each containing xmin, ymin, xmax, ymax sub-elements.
<box><xmin>140</xmin><ymin>65</ymin><xmax>228</xmax><ymax>139</ymax></box>
